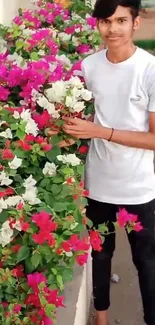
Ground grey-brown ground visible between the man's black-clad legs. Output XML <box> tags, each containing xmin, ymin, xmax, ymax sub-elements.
<box><xmin>89</xmin><ymin>231</ymin><xmax>144</xmax><ymax>325</ymax></box>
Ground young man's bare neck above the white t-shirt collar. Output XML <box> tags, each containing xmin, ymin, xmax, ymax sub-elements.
<box><xmin>107</xmin><ymin>43</ymin><xmax>136</xmax><ymax>63</ymax></box>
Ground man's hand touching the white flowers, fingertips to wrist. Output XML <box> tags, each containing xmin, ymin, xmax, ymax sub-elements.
<box><xmin>63</xmin><ymin>117</ymin><xmax>103</xmax><ymax>139</ymax></box>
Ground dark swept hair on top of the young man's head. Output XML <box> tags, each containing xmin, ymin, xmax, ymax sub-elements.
<box><xmin>93</xmin><ymin>0</ymin><xmax>141</xmax><ymax>19</ymax></box>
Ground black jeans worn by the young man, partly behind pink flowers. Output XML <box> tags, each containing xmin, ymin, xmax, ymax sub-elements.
<box><xmin>87</xmin><ymin>199</ymin><xmax>155</xmax><ymax>325</ymax></box>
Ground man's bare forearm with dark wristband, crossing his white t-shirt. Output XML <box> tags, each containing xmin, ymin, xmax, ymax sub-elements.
<box><xmin>98</xmin><ymin>127</ymin><xmax>155</xmax><ymax>150</ymax></box>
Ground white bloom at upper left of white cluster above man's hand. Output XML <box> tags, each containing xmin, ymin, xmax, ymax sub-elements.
<box><xmin>45</xmin><ymin>81</ymin><xmax>66</xmax><ymax>103</ymax></box>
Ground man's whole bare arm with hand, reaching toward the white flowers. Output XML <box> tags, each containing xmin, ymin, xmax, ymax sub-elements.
<box><xmin>64</xmin><ymin>112</ymin><xmax>155</xmax><ymax>150</ymax></box>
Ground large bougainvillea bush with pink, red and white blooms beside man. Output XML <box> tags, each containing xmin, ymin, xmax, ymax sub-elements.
<box><xmin>0</xmin><ymin>2</ymin><xmax>142</xmax><ymax>325</ymax></box>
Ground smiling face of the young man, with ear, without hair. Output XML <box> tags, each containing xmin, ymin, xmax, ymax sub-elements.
<box><xmin>97</xmin><ymin>6</ymin><xmax>140</xmax><ymax>49</ymax></box>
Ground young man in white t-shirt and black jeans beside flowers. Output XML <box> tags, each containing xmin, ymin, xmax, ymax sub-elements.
<box><xmin>64</xmin><ymin>0</ymin><xmax>155</xmax><ymax>325</ymax></box>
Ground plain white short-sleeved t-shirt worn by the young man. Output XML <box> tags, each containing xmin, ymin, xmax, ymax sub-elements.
<box><xmin>82</xmin><ymin>48</ymin><xmax>155</xmax><ymax>204</ymax></box>
